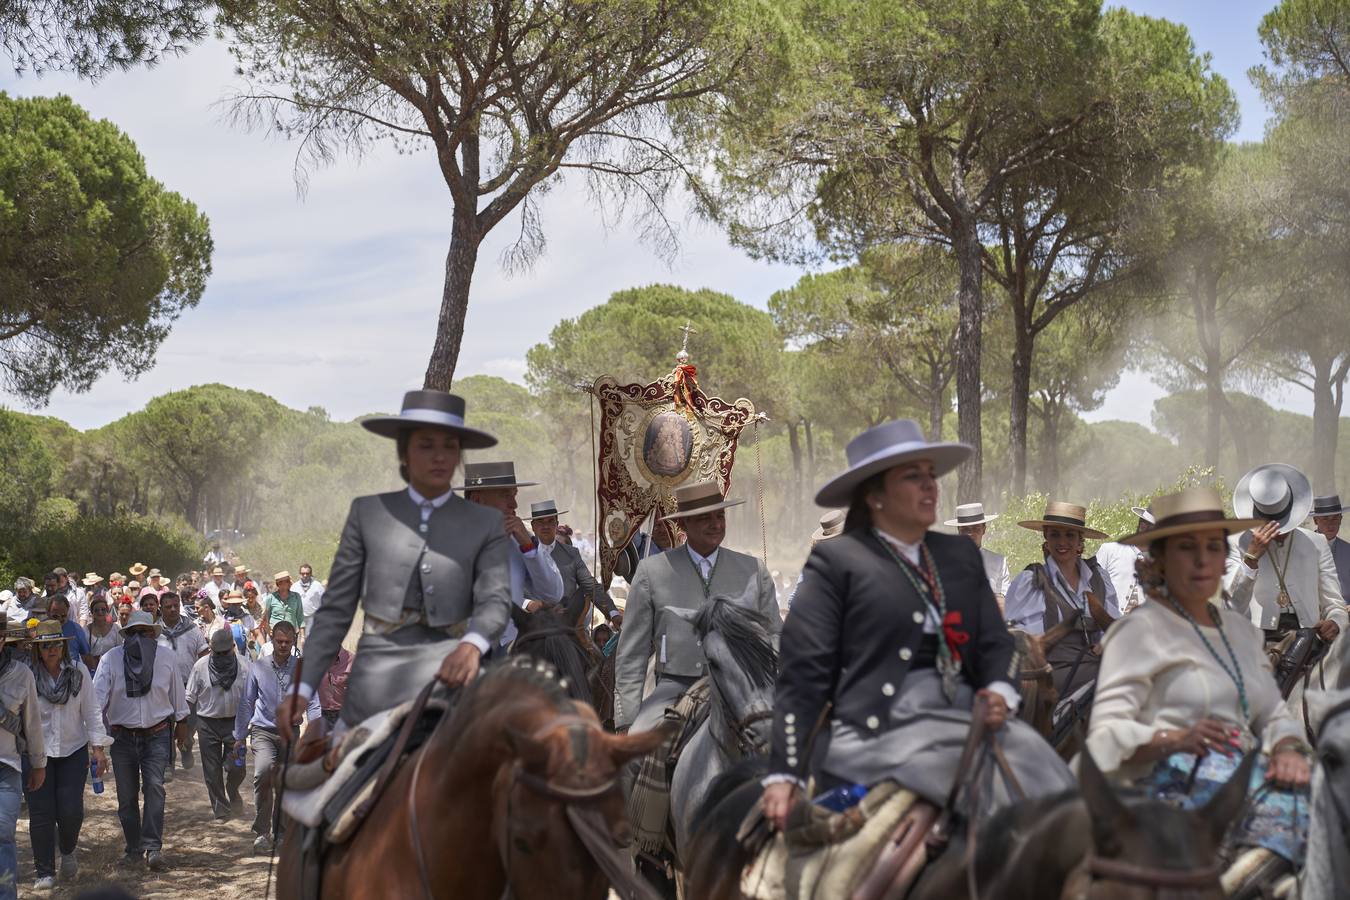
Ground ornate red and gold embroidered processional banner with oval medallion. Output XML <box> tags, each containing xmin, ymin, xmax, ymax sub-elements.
<box><xmin>590</xmin><ymin>329</ymin><xmax>755</xmax><ymax>586</ymax></box>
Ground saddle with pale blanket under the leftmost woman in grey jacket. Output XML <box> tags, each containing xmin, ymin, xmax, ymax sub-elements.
<box><xmin>281</xmin><ymin>691</ymin><xmax>450</xmax><ymax>843</ymax></box>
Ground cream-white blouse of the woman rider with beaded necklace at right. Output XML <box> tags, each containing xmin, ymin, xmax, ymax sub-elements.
<box><xmin>1087</xmin><ymin>602</ymin><xmax>1303</xmax><ymax>779</ymax></box>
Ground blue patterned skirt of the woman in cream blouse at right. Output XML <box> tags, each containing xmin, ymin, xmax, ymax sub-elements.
<box><xmin>1135</xmin><ymin>753</ymin><xmax>1310</xmax><ymax>869</ymax></box>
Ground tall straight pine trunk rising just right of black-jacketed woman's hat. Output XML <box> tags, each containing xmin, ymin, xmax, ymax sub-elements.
<box><xmin>953</xmin><ymin>219</ymin><xmax>984</xmax><ymax>503</ymax></box>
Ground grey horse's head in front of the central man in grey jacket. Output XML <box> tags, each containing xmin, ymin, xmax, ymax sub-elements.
<box><xmin>694</xmin><ymin>583</ymin><xmax>778</xmax><ymax>756</ymax></box>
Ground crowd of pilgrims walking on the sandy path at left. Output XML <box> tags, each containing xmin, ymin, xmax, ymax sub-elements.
<box><xmin>0</xmin><ymin>564</ymin><xmax>342</xmax><ymax>897</ymax></box>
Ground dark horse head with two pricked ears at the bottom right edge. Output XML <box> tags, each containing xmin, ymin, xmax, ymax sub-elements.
<box><xmin>1065</xmin><ymin>750</ymin><xmax>1257</xmax><ymax>900</ymax></box>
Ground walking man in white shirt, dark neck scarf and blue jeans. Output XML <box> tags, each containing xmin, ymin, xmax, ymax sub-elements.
<box><xmin>93</xmin><ymin>610</ymin><xmax>189</xmax><ymax>872</ymax></box>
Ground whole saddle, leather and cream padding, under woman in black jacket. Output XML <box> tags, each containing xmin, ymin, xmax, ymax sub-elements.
<box><xmin>741</xmin><ymin>781</ymin><xmax>937</xmax><ymax>900</ymax></box>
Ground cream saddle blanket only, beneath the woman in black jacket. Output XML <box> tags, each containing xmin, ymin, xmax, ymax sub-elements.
<box><xmin>741</xmin><ymin>781</ymin><xmax>918</xmax><ymax>900</ymax></box>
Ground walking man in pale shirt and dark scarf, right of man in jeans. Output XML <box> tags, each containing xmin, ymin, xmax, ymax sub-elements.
<box><xmin>185</xmin><ymin>631</ymin><xmax>248</xmax><ymax>822</ymax></box>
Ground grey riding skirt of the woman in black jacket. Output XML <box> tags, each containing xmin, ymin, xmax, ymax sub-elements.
<box><xmin>822</xmin><ymin>668</ymin><xmax>1076</xmax><ymax>818</ymax></box>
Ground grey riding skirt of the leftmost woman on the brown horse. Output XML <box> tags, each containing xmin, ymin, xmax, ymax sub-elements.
<box><xmin>342</xmin><ymin>623</ymin><xmax>459</xmax><ymax>726</ymax></box>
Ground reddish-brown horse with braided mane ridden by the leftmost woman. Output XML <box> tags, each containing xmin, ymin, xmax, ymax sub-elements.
<box><xmin>277</xmin><ymin>657</ymin><xmax>666</xmax><ymax>900</ymax></box>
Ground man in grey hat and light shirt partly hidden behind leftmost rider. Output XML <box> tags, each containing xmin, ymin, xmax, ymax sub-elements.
<box><xmin>455</xmin><ymin>461</ymin><xmax>563</xmax><ymax>646</ymax></box>
